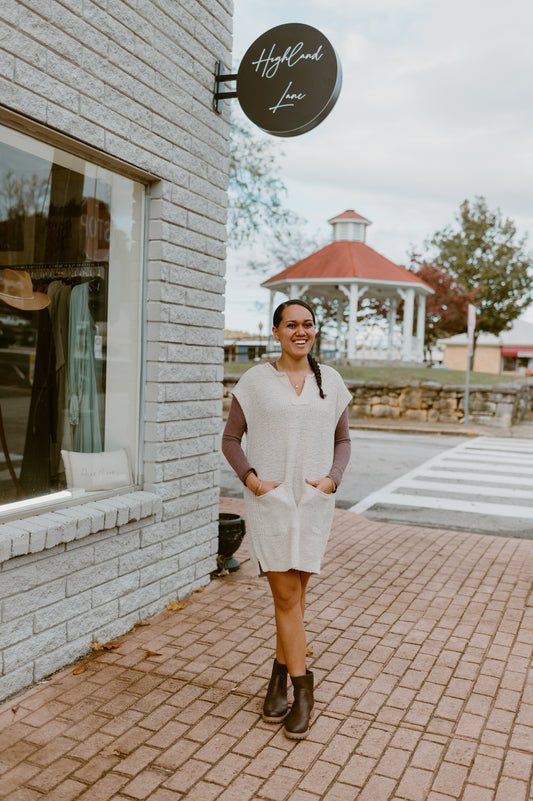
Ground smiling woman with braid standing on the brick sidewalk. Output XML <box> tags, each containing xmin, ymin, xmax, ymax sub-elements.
<box><xmin>222</xmin><ymin>300</ymin><xmax>351</xmax><ymax>739</ymax></box>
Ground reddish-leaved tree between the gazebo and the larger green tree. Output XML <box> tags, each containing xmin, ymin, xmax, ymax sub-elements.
<box><xmin>409</xmin><ymin>254</ymin><xmax>477</xmax><ymax>355</ymax></box>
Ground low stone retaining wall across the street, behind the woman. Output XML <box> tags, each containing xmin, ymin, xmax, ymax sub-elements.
<box><xmin>224</xmin><ymin>375</ymin><xmax>532</xmax><ymax>427</ymax></box>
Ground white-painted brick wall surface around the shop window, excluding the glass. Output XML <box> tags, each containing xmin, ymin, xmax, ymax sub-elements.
<box><xmin>0</xmin><ymin>0</ymin><xmax>233</xmax><ymax>697</ymax></box>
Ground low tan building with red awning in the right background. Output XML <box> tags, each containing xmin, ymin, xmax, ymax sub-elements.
<box><xmin>440</xmin><ymin>320</ymin><xmax>533</xmax><ymax>375</ymax></box>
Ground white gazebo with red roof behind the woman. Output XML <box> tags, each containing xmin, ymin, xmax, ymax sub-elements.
<box><xmin>261</xmin><ymin>209</ymin><xmax>433</xmax><ymax>362</ymax></box>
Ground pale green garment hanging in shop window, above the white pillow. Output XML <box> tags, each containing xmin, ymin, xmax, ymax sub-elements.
<box><xmin>68</xmin><ymin>283</ymin><xmax>103</xmax><ymax>453</ymax></box>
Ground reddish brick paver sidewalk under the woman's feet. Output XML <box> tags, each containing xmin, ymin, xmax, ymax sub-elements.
<box><xmin>0</xmin><ymin>500</ymin><xmax>533</xmax><ymax>801</ymax></box>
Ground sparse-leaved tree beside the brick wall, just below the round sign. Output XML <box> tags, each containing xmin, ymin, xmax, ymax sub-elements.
<box><xmin>228</xmin><ymin>120</ymin><xmax>296</xmax><ymax>248</ymax></box>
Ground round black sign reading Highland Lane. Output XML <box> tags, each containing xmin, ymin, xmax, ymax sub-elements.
<box><xmin>237</xmin><ymin>23</ymin><xmax>342</xmax><ymax>136</ymax></box>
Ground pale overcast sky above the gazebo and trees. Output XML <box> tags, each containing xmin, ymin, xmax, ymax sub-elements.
<box><xmin>226</xmin><ymin>0</ymin><xmax>533</xmax><ymax>332</ymax></box>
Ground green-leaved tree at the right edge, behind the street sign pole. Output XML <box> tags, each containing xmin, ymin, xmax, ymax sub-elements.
<box><xmin>426</xmin><ymin>197</ymin><xmax>533</xmax><ymax>338</ymax></box>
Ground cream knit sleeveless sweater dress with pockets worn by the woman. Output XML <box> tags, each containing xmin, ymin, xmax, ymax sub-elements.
<box><xmin>233</xmin><ymin>364</ymin><xmax>351</xmax><ymax>574</ymax></box>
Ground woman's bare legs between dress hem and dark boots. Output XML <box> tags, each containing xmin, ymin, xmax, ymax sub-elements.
<box><xmin>267</xmin><ymin>570</ymin><xmax>311</xmax><ymax>676</ymax></box>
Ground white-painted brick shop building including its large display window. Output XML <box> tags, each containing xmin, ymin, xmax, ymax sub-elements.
<box><xmin>0</xmin><ymin>0</ymin><xmax>232</xmax><ymax>698</ymax></box>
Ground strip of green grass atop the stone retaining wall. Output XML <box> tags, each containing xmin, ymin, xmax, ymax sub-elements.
<box><xmin>224</xmin><ymin>362</ymin><xmax>531</xmax><ymax>387</ymax></box>
